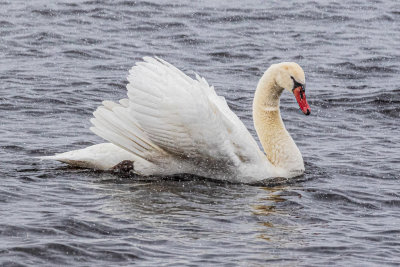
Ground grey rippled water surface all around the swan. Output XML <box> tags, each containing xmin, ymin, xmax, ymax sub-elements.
<box><xmin>0</xmin><ymin>0</ymin><xmax>400</xmax><ymax>266</ymax></box>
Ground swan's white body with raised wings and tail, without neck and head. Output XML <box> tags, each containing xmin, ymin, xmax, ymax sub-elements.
<box><xmin>42</xmin><ymin>57</ymin><xmax>310</xmax><ymax>182</ymax></box>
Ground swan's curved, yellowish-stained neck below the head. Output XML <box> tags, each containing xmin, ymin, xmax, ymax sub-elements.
<box><xmin>253</xmin><ymin>68</ymin><xmax>304</xmax><ymax>171</ymax></box>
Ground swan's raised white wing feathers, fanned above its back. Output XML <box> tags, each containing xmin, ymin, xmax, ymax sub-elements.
<box><xmin>92</xmin><ymin>57</ymin><xmax>263</xmax><ymax>169</ymax></box>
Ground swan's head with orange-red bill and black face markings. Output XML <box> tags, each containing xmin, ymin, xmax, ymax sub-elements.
<box><xmin>275</xmin><ymin>62</ymin><xmax>310</xmax><ymax>115</ymax></box>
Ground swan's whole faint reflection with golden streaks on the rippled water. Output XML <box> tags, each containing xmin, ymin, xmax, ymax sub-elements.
<box><xmin>86</xmin><ymin>173</ymin><xmax>308</xmax><ymax>247</ymax></box>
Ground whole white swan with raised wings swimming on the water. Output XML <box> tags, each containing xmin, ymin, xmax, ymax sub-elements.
<box><xmin>43</xmin><ymin>57</ymin><xmax>310</xmax><ymax>183</ymax></box>
